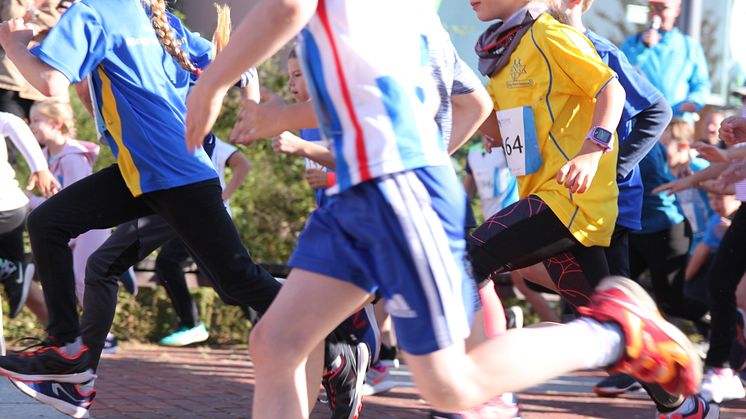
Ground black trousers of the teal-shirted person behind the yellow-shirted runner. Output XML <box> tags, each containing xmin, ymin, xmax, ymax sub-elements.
<box><xmin>629</xmin><ymin>220</ymin><xmax>707</xmax><ymax>321</ymax></box>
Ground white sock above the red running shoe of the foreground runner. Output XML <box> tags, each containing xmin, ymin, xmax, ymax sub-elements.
<box><xmin>567</xmin><ymin>317</ymin><xmax>624</xmax><ymax>369</ymax></box>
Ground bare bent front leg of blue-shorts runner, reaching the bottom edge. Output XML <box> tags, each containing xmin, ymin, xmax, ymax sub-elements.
<box><xmin>250</xmin><ymin>269</ymin><xmax>369</xmax><ymax>418</ymax></box>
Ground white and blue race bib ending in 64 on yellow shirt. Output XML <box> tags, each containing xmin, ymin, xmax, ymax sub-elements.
<box><xmin>496</xmin><ymin>106</ymin><xmax>543</xmax><ymax>176</ymax></box>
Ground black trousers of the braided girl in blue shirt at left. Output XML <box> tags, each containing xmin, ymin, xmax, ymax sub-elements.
<box><xmin>28</xmin><ymin>165</ymin><xmax>280</xmax><ymax>348</ymax></box>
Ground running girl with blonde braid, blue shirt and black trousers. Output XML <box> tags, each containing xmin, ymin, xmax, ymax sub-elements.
<box><xmin>0</xmin><ymin>0</ymin><xmax>280</xmax><ymax>414</ymax></box>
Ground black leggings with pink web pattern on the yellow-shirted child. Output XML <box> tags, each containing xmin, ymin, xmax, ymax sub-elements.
<box><xmin>469</xmin><ymin>195</ymin><xmax>609</xmax><ymax>307</ymax></box>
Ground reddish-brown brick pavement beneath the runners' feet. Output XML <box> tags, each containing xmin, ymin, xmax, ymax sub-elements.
<box><xmin>83</xmin><ymin>345</ymin><xmax>746</xmax><ymax>419</ymax></box>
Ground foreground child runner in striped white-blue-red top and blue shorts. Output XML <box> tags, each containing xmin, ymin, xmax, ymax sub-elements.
<box><xmin>187</xmin><ymin>0</ymin><xmax>700</xmax><ymax>418</ymax></box>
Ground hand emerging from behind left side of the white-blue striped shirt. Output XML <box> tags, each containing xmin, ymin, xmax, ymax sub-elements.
<box><xmin>229</xmin><ymin>89</ymin><xmax>285</xmax><ymax>144</ymax></box>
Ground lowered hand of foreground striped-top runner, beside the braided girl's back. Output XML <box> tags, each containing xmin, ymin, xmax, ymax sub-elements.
<box><xmin>186</xmin><ymin>78</ymin><xmax>226</xmax><ymax>151</ymax></box>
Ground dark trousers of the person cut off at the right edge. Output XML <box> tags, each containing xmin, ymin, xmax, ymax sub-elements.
<box><xmin>705</xmin><ymin>204</ymin><xmax>746</xmax><ymax>367</ymax></box>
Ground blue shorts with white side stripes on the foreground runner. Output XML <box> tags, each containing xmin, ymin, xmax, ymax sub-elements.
<box><xmin>290</xmin><ymin>166</ymin><xmax>476</xmax><ymax>355</ymax></box>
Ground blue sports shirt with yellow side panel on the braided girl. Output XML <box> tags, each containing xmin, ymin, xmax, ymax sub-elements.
<box><xmin>31</xmin><ymin>0</ymin><xmax>217</xmax><ymax>196</ymax></box>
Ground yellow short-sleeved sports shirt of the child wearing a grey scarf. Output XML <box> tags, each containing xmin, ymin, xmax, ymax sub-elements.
<box><xmin>487</xmin><ymin>13</ymin><xmax>618</xmax><ymax>246</ymax></box>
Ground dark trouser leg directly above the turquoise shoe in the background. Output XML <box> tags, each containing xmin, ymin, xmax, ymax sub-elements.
<box><xmin>155</xmin><ymin>238</ymin><xmax>199</xmax><ymax>328</ymax></box>
